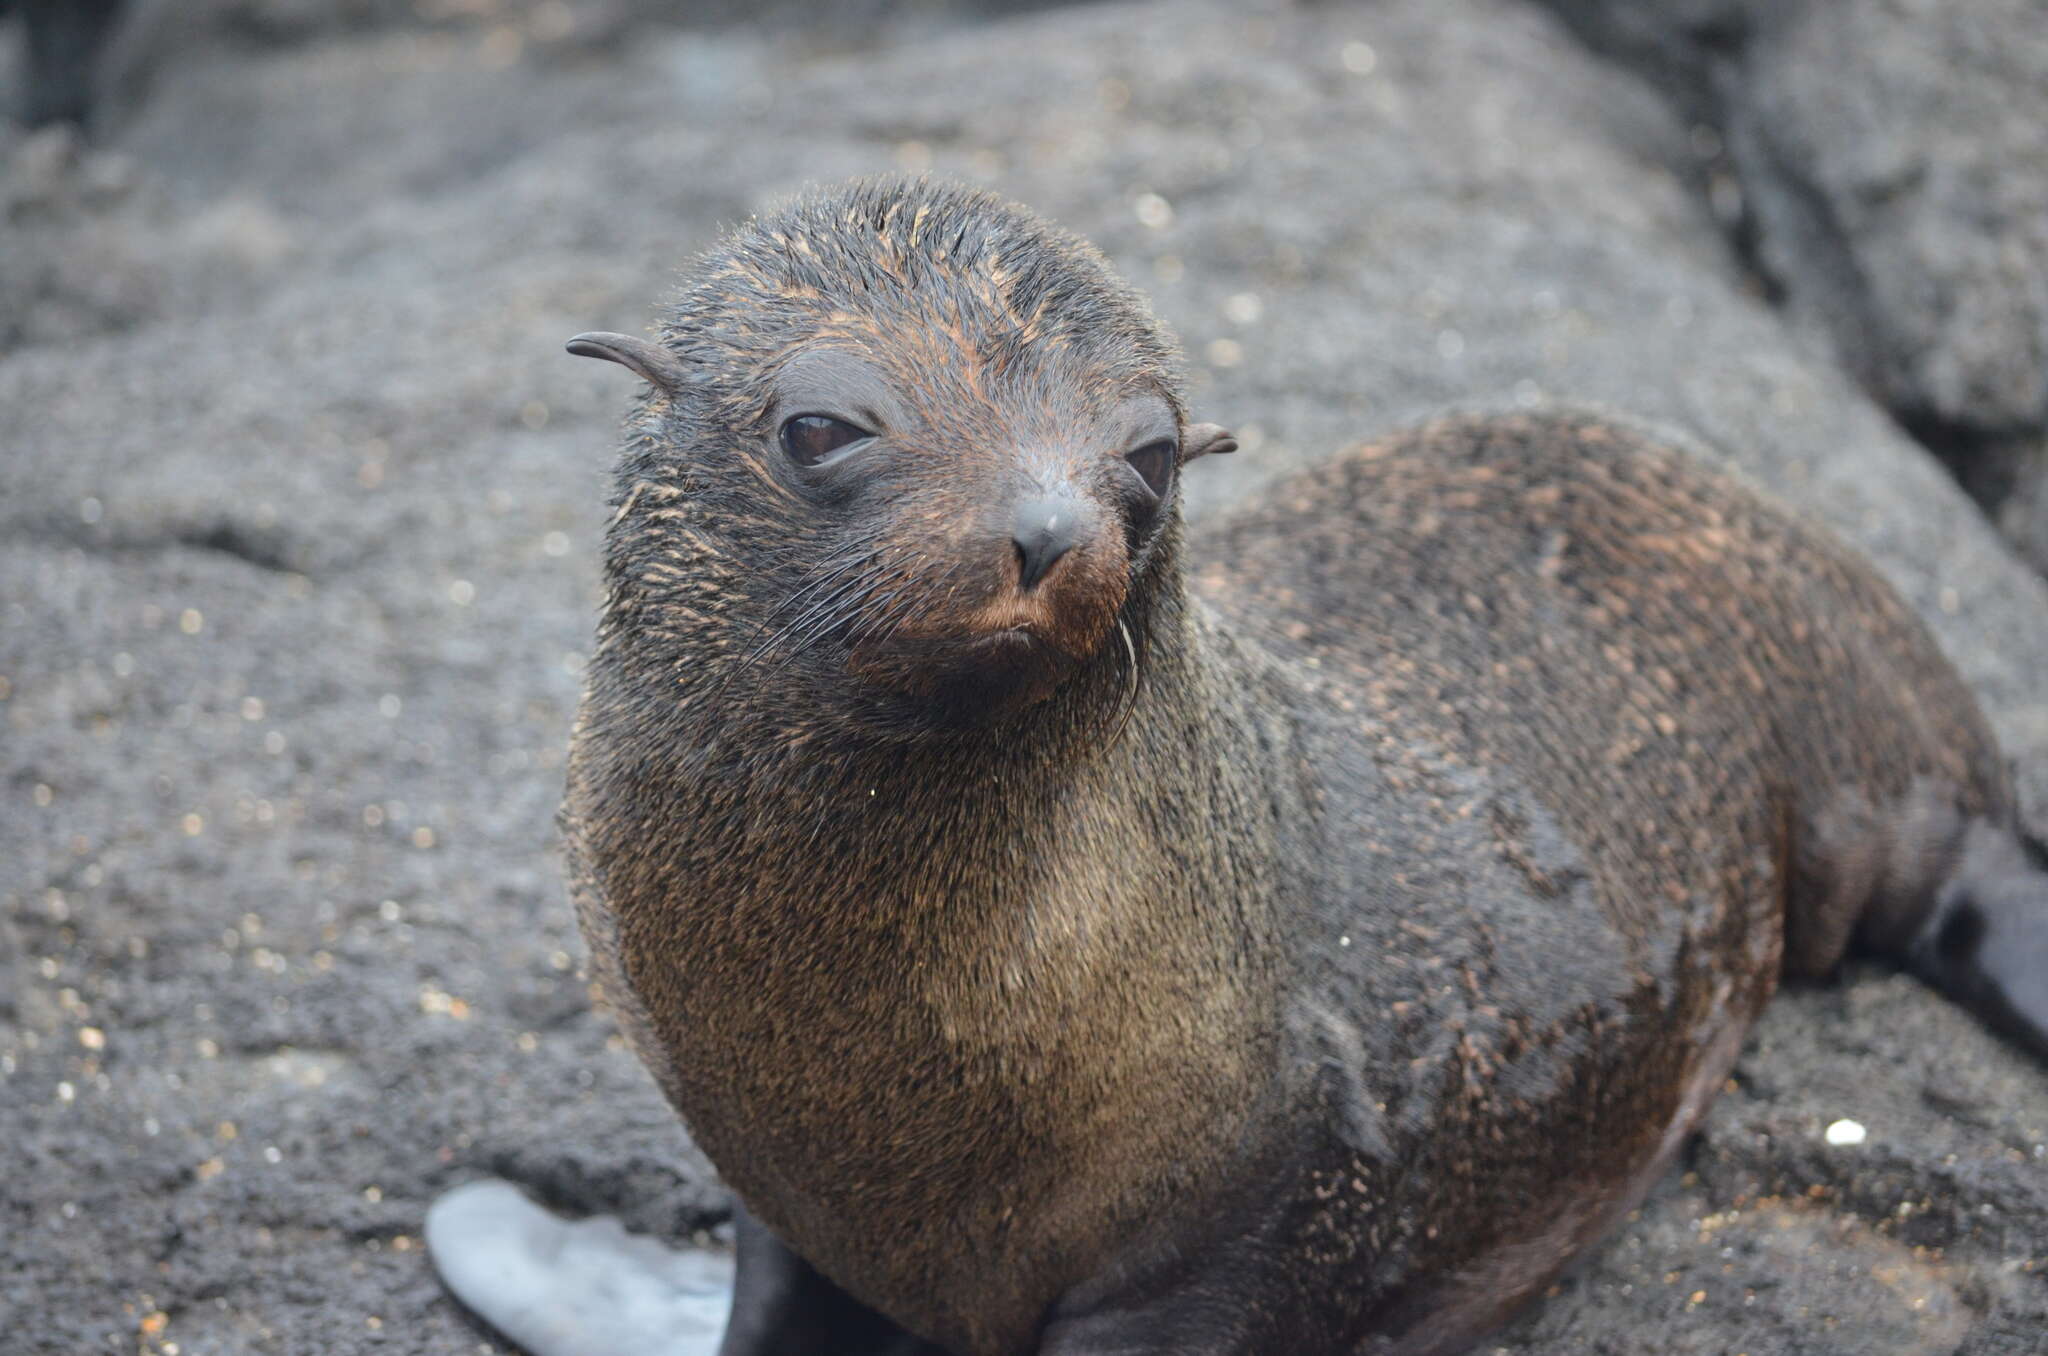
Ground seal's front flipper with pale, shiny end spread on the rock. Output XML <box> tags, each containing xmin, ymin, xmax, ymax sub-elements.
<box><xmin>426</xmin><ymin>1182</ymin><xmax>942</xmax><ymax>1356</ymax></box>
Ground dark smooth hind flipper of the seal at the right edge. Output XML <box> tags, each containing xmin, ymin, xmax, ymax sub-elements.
<box><xmin>1903</xmin><ymin>821</ymin><xmax>2048</xmax><ymax>1059</ymax></box>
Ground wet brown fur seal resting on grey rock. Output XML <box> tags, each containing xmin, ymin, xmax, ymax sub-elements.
<box><xmin>436</xmin><ymin>180</ymin><xmax>2048</xmax><ymax>1356</ymax></box>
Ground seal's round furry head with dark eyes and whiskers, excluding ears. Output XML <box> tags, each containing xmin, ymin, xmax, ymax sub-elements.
<box><xmin>612</xmin><ymin>184</ymin><xmax>1186</xmax><ymax>737</ymax></box>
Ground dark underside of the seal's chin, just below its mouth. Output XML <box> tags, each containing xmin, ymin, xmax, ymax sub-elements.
<box><xmin>848</xmin><ymin>627</ymin><xmax>1081</xmax><ymax>729</ymax></box>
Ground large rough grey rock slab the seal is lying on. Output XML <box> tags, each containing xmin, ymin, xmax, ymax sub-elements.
<box><xmin>0</xmin><ymin>0</ymin><xmax>2048</xmax><ymax>1356</ymax></box>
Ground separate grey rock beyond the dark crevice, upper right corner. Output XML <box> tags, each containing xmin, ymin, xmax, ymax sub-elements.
<box><xmin>1550</xmin><ymin>0</ymin><xmax>2048</xmax><ymax>569</ymax></box>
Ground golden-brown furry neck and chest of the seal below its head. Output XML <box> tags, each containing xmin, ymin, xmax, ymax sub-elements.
<box><xmin>567</xmin><ymin>536</ymin><xmax>1303</xmax><ymax>1350</ymax></box>
